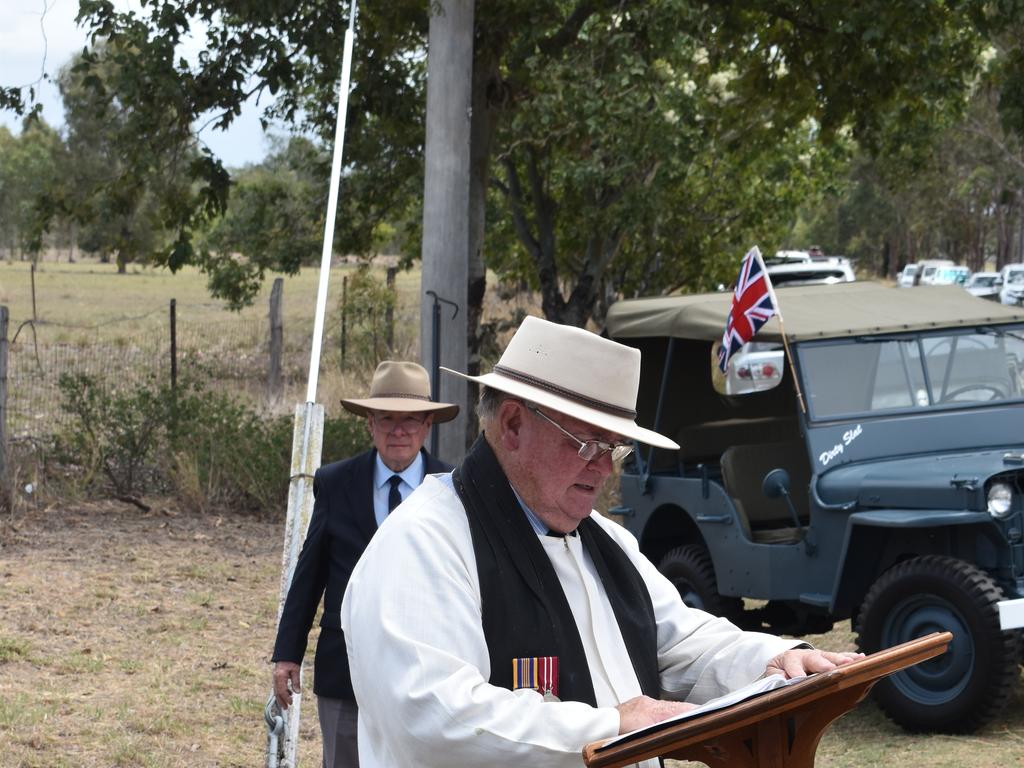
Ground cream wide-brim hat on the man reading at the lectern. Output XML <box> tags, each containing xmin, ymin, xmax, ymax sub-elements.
<box><xmin>441</xmin><ymin>316</ymin><xmax>679</xmax><ymax>451</ymax></box>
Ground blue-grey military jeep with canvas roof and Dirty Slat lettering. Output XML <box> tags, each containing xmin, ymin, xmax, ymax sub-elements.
<box><xmin>606</xmin><ymin>283</ymin><xmax>1024</xmax><ymax>732</ymax></box>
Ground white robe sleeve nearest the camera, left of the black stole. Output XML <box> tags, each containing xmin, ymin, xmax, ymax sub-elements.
<box><xmin>342</xmin><ymin>480</ymin><xmax>618</xmax><ymax>768</ymax></box>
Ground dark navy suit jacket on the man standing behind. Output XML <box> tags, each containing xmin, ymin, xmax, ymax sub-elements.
<box><xmin>271</xmin><ymin>449</ymin><xmax>452</xmax><ymax>700</ymax></box>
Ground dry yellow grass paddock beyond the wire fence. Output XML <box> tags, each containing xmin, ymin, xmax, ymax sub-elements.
<box><xmin>0</xmin><ymin>260</ymin><xmax>420</xmax><ymax>411</ymax></box>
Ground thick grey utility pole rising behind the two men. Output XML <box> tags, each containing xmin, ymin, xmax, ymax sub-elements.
<box><xmin>420</xmin><ymin>0</ymin><xmax>475</xmax><ymax>462</ymax></box>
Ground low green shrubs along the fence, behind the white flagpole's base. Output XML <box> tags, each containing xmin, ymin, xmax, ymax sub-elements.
<box><xmin>51</xmin><ymin>375</ymin><xmax>370</xmax><ymax>513</ymax></box>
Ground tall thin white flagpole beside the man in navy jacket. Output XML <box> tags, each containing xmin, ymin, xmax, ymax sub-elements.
<box><xmin>264</xmin><ymin>6</ymin><xmax>356</xmax><ymax>768</ymax></box>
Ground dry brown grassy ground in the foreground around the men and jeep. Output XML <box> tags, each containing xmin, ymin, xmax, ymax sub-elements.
<box><xmin>0</xmin><ymin>500</ymin><xmax>1024</xmax><ymax>768</ymax></box>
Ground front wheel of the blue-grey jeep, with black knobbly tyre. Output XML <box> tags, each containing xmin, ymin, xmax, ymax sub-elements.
<box><xmin>857</xmin><ymin>555</ymin><xmax>1020</xmax><ymax>733</ymax></box>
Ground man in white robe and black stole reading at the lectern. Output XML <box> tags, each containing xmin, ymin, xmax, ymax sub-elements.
<box><xmin>341</xmin><ymin>317</ymin><xmax>856</xmax><ymax>768</ymax></box>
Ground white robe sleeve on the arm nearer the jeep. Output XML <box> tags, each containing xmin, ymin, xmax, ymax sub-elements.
<box><xmin>595</xmin><ymin>515</ymin><xmax>801</xmax><ymax>703</ymax></box>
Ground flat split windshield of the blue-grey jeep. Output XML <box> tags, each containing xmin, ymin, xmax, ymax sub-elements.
<box><xmin>799</xmin><ymin>325</ymin><xmax>1024</xmax><ymax>421</ymax></box>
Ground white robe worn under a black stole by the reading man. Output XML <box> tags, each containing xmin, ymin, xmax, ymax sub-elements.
<box><xmin>341</xmin><ymin>475</ymin><xmax>800</xmax><ymax>768</ymax></box>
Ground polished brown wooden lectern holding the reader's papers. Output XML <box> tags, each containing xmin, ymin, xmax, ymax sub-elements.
<box><xmin>583</xmin><ymin>632</ymin><xmax>952</xmax><ymax>768</ymax></box>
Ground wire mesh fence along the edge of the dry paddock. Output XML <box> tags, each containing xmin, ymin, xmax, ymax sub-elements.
<box><xmin>6</xmin><ymin>286</ymin><xmax>419</xmax><ymax>441</ymax></box>
